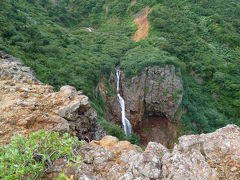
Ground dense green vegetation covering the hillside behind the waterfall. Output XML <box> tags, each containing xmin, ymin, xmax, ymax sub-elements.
<box><xmin>0</xmin><ymin>0</ymin><xmax>240</xmax><ymax>136</ymax></box>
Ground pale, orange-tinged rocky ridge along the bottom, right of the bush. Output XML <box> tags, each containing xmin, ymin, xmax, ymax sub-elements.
<box><xmin>46</xmin><ymin>125</ymin><xmax>240</xmax><ymax>180</ymax></box>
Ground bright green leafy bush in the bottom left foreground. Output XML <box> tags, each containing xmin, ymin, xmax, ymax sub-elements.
<box><xmin>0</xmin><ymin>130</ymin><xmax>82</xmax><ymax>180</ymax></box>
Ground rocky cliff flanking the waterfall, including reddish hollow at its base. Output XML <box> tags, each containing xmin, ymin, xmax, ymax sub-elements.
<box><xmin>99</xmin><ymin>65</ymin><xmax>183</xmax><ymax>145</ymax></box>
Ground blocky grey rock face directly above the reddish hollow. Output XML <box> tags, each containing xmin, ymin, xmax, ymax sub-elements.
<box><xmin>142</xmin><ymin>66</ymin><xmax>183</xmax><ymax>120</ymax></box>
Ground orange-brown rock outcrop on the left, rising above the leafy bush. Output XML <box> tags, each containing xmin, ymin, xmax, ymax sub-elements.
<box><xmin>0</xmin><ymin>52</ymin><xmax>105</xmax><ymax>145</ymax></box>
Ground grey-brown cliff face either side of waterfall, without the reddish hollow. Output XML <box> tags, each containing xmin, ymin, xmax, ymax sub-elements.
<box><xmin>100</xmin><ymin>65</ymin><xmax>183</xmax><ymax>127</ymax></box>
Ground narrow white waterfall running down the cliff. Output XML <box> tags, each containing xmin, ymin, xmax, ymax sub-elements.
<box><xmin>116</xmin><ymin>68</ymin><xmax>132</xmax><ymax>135</ymax></box>
